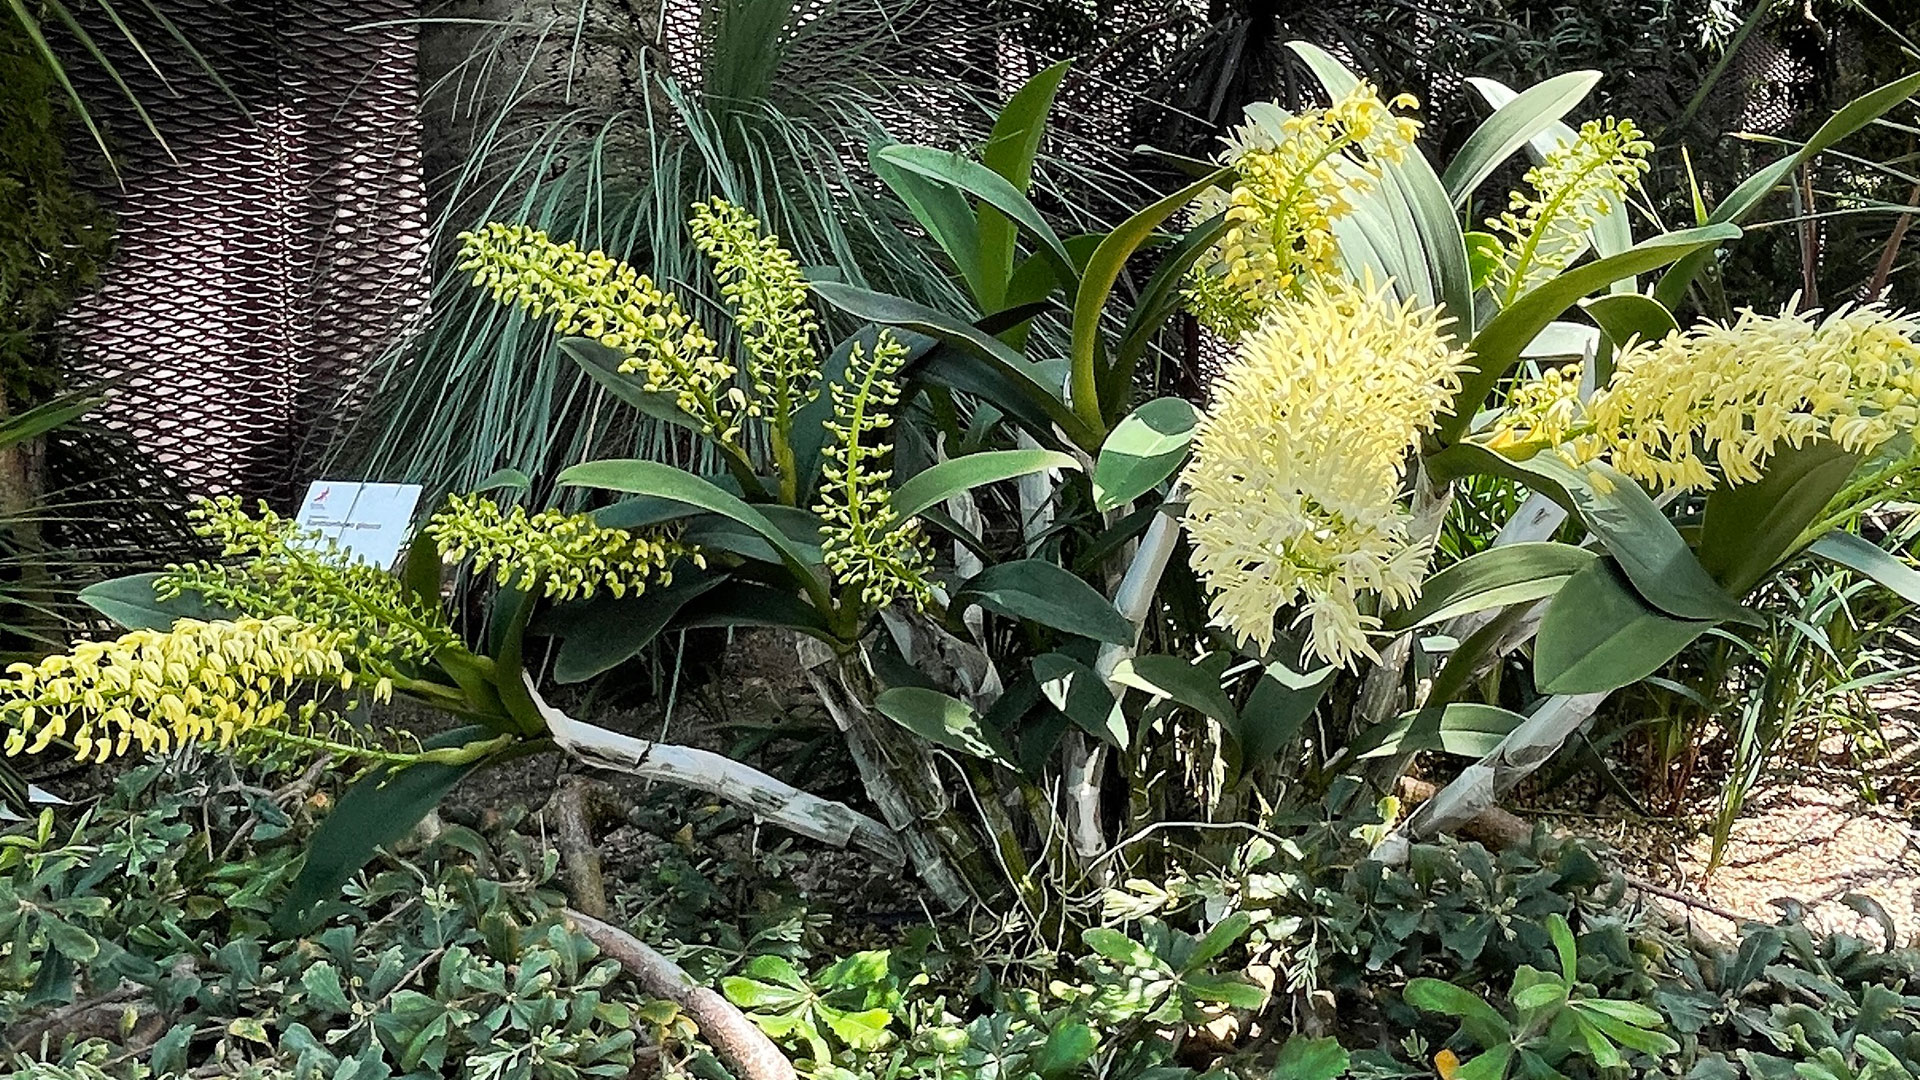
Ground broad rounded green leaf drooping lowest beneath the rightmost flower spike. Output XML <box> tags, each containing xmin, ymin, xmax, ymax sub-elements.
<box><xmin>1534</xmin><ymin>561</ymin><xmax>1713</xmax><ymax>694</ymax></box>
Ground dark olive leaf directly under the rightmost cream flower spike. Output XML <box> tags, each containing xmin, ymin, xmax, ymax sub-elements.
<box><xmin>1699</xmin><ymin>442</ymin><xmax>1860</xmax><ymax>596</ymax></box>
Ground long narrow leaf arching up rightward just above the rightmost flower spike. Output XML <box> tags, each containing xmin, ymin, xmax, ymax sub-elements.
<box><xmin>1440</xmin><ymin>225</ymin><xmax>1740</xmax><ymax>442</ymax></box>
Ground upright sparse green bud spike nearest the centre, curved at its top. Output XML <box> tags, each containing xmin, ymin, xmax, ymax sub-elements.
<box><xmin>814</xmin><ymin>331</ymin><xmax>933</xmax><ymax>607</ymax></box>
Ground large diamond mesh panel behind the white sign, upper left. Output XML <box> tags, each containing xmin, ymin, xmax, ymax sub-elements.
<box><xmin>62</xmin><ymin>0</ymin><xmax>426</xmax><ymax>498</ymax></box>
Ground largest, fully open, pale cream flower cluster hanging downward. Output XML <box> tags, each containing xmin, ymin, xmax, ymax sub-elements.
<box><xmin>1183</xmin><ymin>282</ymin><xmax>1463</xmax><ymax>663</ymax></box>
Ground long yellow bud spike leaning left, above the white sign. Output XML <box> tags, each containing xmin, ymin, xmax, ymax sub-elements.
<box><xmin>461</xmin><ymin>221</ymin><xmax>753</xmax><ymax>444</ymax></box>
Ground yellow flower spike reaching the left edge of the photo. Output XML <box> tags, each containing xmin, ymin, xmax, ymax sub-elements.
<box><xmin>0</xmin><ymin>615</ymin><xmax>359</xmax><ymax>761</ymax></box>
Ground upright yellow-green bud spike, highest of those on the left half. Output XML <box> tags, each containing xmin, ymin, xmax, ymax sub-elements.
<box><xmin>687</xmin><ymin>198</ymin><xmax>820</xmax><ymax>423</ymax></box>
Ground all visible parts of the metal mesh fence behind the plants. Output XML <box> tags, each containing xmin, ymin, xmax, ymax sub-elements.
<box><xmin>52</xmin><ymin>0</ymin><xmax>1896</xmax><ymax>496</ymax></box>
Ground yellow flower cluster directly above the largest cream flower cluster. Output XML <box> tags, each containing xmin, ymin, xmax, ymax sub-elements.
<box><xmin>1187</xmin><ymin>83</ymin><xmax>1421</xmax><ymax>336</ymax></box>
